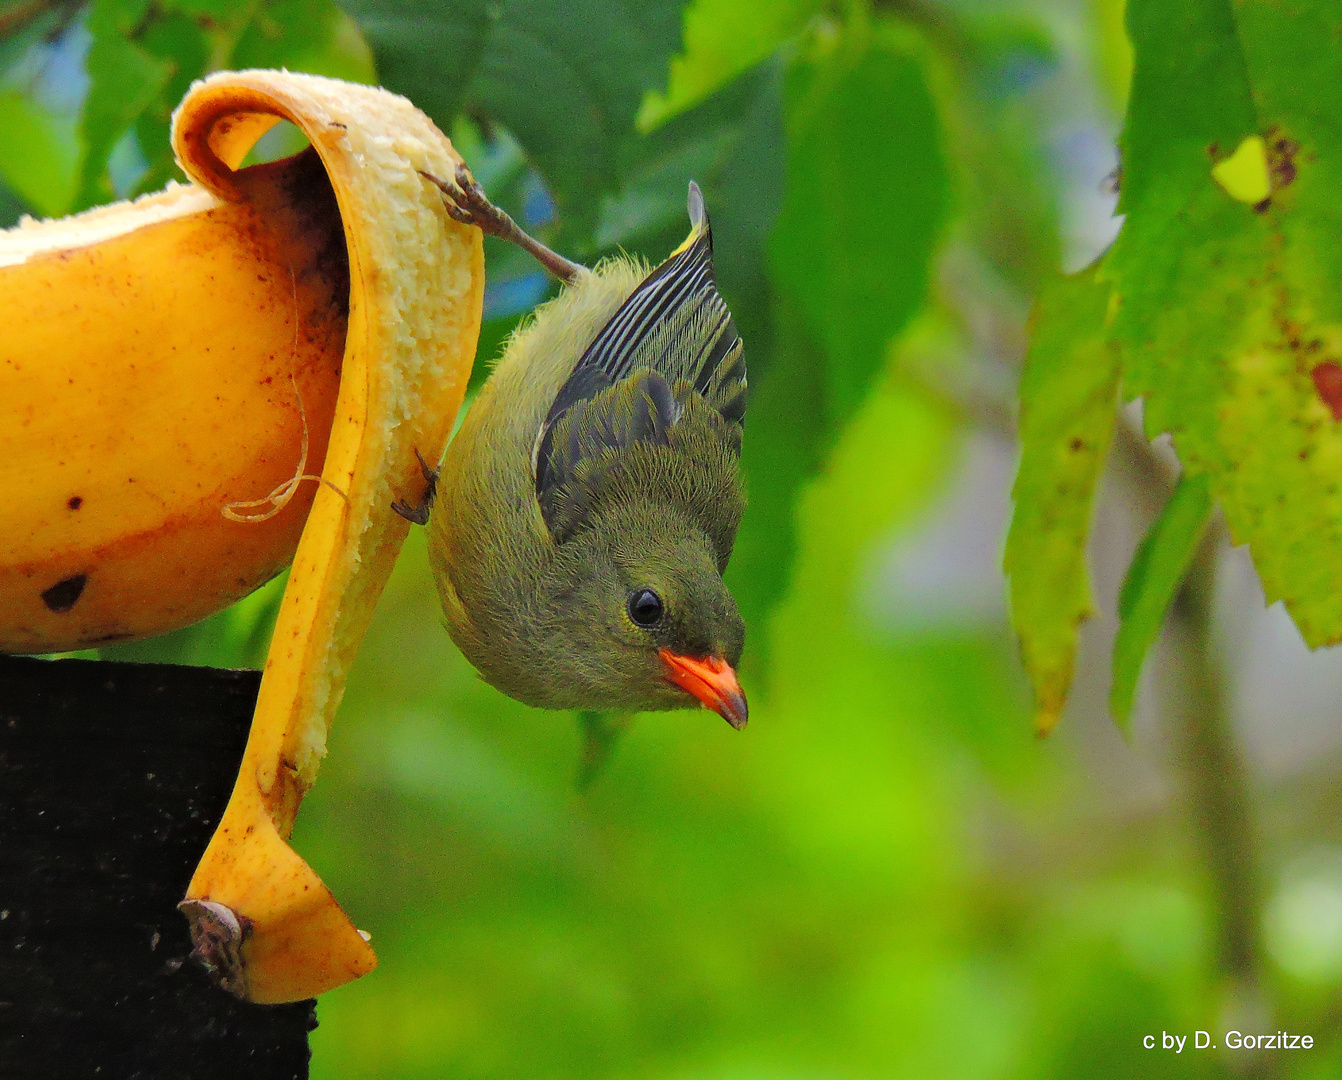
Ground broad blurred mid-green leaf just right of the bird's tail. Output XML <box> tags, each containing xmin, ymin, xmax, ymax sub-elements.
<box><xmin>770</xmin><ymin>27</ymin><xmax>949</xmax><ymax>428</ymax></box>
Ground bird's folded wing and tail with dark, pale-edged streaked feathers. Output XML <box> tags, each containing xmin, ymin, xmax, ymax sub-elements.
<box><xmin>534</xmin><ymin>184</ymin><xmax>746</xmax><ymax>533</ymax></box>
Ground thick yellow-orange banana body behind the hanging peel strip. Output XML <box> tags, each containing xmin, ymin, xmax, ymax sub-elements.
<box><xmin>0</xmin><ymin>138</ymin><xmax>349</xmax><ymax>652</ymax></box>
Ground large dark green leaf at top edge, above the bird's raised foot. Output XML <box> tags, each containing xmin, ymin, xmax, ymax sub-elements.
<box><xmin>344</xmin><ymin>0</ymin><xmax>680</xmax><ymax>229</ymax></box>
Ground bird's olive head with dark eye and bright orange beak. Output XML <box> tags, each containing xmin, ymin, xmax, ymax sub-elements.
<box><xmin>557</xmin><ymin>506</ymin><xmax>747</xmax><ymax>728</ymax></box>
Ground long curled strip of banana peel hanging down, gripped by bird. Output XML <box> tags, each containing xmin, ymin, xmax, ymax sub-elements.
<box><xmin>173</xmin><ymin>71</ymin><xmax>483</xmax><ymax>1002</ymax></box>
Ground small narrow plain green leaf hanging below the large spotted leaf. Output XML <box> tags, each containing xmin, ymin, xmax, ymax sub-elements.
<box><xmin>1108</xmin><ymin>475</ymin><xmax>1212</xmax><ymax>731</ymax></box>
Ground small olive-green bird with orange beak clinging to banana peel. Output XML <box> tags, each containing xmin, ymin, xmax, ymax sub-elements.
<box><xmin>396</xmin><ymin>168</ymin><xmax>747</xmax><ymax>728</ymax></box>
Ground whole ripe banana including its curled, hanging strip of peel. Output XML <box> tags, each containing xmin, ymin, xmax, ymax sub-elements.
<box><xmin>0</xmin><ymin>71</ymin><xmax>484</xmax><ymax>1002</ymax></box>
